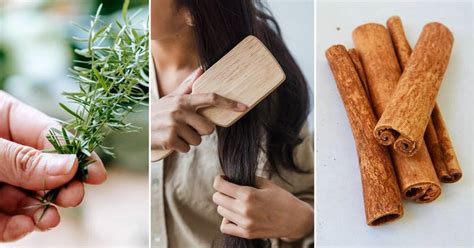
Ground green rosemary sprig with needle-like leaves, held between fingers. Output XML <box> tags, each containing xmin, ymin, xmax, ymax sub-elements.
<box><xmin>39</xmin><ymin>0</ymin><xmax>149</xmax><ymax>214</ymax></box>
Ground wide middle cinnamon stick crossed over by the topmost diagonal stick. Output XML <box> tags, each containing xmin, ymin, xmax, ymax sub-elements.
<box><xmin>352</xmin><ymin>23</ymin><xmax>441</xmax><ymax>203</ymax></box>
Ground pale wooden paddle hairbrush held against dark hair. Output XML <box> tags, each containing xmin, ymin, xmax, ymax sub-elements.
<box><xmin>151</xmin><ymin>35</ymin><xmax>286</xmax><ymax>161</ymax></box>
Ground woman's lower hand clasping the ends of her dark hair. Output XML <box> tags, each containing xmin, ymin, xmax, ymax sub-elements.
<box><xmin>212</xmin><ymin>176</ymin><xmax>314</xmax><ymax>241</ymax></box>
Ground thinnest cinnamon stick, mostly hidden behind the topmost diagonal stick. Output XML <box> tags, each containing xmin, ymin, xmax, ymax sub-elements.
<box><xmin>387</xmin><ymin>16</ymin><xmax>462</xmax><ymax>183</ymax></box>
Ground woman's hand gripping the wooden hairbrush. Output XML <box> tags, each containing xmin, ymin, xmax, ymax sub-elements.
<box><xmin>151</xmin><ymin>69</ymin><xmax>247</xmax><ymax>152</ymax></box>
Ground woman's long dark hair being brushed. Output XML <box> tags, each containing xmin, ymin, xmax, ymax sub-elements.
<box><xmin>177</xmin><ymin>0</ymin><xmax>310</xmax><ymax>247</ymax></box>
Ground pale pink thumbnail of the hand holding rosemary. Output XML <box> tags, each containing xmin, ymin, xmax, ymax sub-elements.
<box><xmin>43</xmin><ymin>153</ymin><xmax>76</xmax><ymax>176</ymax></box>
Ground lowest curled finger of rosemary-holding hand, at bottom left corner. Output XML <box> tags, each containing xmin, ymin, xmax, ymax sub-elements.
<box><xmin>0</xmin><ymin>213</ymin><xmax>35</xmax><ymax>242</ymax></box>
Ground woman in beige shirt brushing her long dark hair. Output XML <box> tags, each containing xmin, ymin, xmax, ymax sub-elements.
<box><xmin>151</xmin><ymin>0</ymin><xmax>313</xmax><ymax>247</ymax></box>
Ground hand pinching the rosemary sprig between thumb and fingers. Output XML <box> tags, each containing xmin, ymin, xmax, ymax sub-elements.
<box><xmin>0</xmin><ymin>91</ymin><xmax>107</xmax><ymax>242</ymax></box>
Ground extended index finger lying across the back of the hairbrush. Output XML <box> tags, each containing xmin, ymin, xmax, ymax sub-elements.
<box><xmin>189</xmin><ymin>93</ymin><xmax>247</xmax><ymax>112</ymax></box>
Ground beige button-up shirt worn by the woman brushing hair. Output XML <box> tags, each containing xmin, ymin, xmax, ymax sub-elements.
<box><xmin>150</xmin><ymin>59</ymin><xmax>314</xmax><ymax>248</ymax></box>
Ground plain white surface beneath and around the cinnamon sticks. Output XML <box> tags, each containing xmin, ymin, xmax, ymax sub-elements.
<box><xmin>316</xmin><ymin>2</ymin><xmax>474</xmax><ymax>247</ymax></box>
